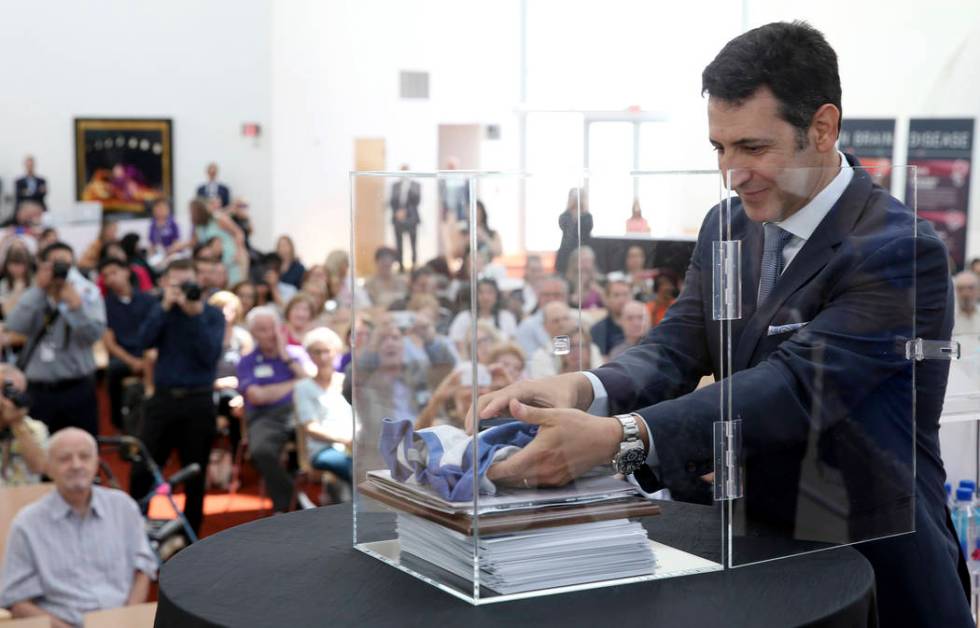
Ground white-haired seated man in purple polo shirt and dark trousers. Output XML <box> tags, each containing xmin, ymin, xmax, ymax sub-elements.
<box><xmin>238</xmin><ymin>305</ymin><xmax>316</xmax><ymax>512</ymax></box>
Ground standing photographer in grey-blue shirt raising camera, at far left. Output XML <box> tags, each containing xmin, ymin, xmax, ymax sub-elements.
<box><xmin>7</xmin><ymin>242</ymin><xmax>106</xmax><ymax>435</ymax></box>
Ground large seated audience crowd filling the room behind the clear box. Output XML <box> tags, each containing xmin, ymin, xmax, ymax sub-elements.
<box><xmin>0</xmin><ymin>167</ymin><xmax>696</xmax><ymax>621</ymax></box>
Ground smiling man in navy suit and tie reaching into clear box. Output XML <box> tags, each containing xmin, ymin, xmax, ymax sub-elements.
<box><xmin>477</xmin><ymin>23</ymin><xmax>971</xmax><ymax>626</ymax></box>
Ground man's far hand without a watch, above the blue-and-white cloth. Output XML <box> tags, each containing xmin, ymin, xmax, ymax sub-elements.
<box><xmin>466</xmin><ymin>373</ymin><xmax>593</xmax><ymax>433</ymax></box>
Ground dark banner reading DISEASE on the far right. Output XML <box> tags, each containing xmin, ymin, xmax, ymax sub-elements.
<box><xmin>905</xmin><ymin>118</ymin><xmax>974</xmax><ymax>269</ymax></box>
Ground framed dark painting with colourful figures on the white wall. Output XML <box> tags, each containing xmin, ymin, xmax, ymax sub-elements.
<box><xmin>75</xmin><ymin>118</ymin><xmax>173</xmax><ymax>218</ymax></box>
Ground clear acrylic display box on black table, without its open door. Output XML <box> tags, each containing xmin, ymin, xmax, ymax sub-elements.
<box><xmin>351</xmin><ymin>172</ymin><xmax>724</xmax><ymax>604</ymax></box>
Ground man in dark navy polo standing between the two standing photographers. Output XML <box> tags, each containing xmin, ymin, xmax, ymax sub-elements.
<box><xmin>99</xmin><ymin>257</ymin><xmax>156</xmax><ymax>430</ymax></box>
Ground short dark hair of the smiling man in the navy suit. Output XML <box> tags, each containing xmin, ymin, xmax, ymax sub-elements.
<box><xmin>701</xmin><ymin>21</ymin><xmax>841</xmax><ymax>149</ymax></box>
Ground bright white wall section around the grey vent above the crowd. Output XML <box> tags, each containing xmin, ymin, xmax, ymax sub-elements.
<box><xmin>272</xmin><ymin>0</ymin><xmax>519</xmax><ymax>262</ymax></box>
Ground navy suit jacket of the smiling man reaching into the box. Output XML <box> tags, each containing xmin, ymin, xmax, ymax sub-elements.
<box><xmin>593</xmin><ymin>157</ymin><xmax>969</xmax><ymax>626</ymax></box>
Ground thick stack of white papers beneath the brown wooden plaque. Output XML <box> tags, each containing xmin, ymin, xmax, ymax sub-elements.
<box><xmin>397</xmin><ymin>513</ymin><xmax>656</xmax><ymax>595</ymax></box>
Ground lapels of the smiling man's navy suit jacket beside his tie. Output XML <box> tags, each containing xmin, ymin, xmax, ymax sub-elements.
<box><xmin>732</xmin><ymin>161</ymin><xmax>871</xmax><ymax>371</ymax></box>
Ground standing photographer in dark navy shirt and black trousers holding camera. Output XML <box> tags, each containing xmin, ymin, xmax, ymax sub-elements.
<box><xmin>130</xmin><ymin>259</ymin><xmax>225</xmax><ymax>532</ymax></box>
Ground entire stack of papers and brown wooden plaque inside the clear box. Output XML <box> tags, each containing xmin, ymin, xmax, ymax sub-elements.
<box><xmin>358</xmin><ymin>470</ymin><xmax>660</xmax><ymax>595</ymax></box>
